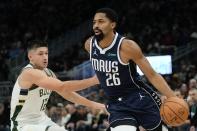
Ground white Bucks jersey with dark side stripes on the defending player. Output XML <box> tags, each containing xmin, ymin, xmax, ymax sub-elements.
<box><xmin>10</xmin><ymin>64</ymin><xmax>55</xmax><ymax>127</ymax></box>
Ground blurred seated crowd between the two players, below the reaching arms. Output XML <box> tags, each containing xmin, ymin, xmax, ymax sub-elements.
<box><xmin>47</xmin><ymin>88</ymin><xmax>109</xmax><ymax>131</ymax></box>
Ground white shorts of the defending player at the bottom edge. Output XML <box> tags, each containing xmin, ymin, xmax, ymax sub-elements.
<box><xmin>12</xmin><ymin>119</ymin><xmax>66</xmax><ymax>131</ymax></box>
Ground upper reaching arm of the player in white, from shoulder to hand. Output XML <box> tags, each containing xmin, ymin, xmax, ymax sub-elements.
<box><xmin>19</xmin><ymin>69</ymin><xmax>98</xmax><ymax>92</ymax></box>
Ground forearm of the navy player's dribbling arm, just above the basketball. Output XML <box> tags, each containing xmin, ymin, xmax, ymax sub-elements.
<box><xmin>149</xmin><ymin>73</ymin><xmax>175</xmax><ymax>97</ymax></box>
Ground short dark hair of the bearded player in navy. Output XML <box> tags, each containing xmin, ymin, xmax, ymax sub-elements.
<box><xmin>96</xmin><ymin>8</ymin><xmax>118</xmax><ymax>23</ymax></box>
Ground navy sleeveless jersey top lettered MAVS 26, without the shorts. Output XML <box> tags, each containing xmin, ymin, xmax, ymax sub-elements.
<box><xmin>90</xmin><ymin>33</ymin><xmax>145</xmax><ymax>96</ymax></box>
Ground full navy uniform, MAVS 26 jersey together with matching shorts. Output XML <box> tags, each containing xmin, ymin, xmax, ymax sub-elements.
<box><xmin>90</xmin><ymin>33</ymin><xmax>161</xmax><ymax>130</ymax></box>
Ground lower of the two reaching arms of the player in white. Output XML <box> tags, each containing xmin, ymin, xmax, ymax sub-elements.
<box><xmin>58</xmin><ymin>92</ymin><xmax>106</xmax><ymax>110</ymax></box>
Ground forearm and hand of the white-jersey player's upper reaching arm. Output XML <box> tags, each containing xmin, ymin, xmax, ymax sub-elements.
<box><xmin>62</xmin><ymin>77</ymin><xmax>98</xmax><ymax>92</ymax></box>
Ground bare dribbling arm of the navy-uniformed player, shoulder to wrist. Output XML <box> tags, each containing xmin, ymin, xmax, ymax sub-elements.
<box><xmin>121</xmin><ymin>40</ymin><xmax>175</xmax><ymax>97</ymax></box>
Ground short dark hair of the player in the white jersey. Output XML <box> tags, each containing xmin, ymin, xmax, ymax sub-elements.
<box><xmin>27</xmin><ymin>40</ymin><xmax>48</xmax><ymax>51</ymax></box>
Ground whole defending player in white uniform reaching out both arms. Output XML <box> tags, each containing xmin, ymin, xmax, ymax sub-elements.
<box><xmin>10</xmin><ymin>41</ymin><xmax>105</xmax><ymax>131</ymax></box>
